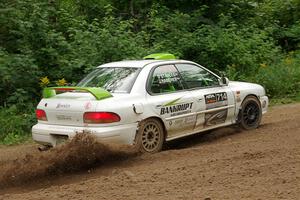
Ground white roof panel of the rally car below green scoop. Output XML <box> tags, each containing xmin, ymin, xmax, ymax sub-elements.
<box><xmin>97</xmin><ymin>59</ymin><xmax>192</xmax><ymax>68</ymax></box>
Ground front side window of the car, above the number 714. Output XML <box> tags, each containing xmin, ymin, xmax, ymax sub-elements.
<box><xmin>176</xmin><ymin>64</ymin><xmax>220</xmax><ymax>88</ymax></box>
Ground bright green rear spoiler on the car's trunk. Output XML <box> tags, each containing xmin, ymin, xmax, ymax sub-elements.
<box><xmin>43</xmin><ymin>86</ymin><xmax>112</xmax><ymax>100</ymax></box>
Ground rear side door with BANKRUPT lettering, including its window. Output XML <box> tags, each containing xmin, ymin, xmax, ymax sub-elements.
<box><xmin>147</xmin><ymin>65</ymin><xmax>196</xmax><ymax>139</ymax></box>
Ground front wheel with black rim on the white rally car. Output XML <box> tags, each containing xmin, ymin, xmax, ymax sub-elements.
<box><xmin>240</xmin><ymin>96</ymin><xmax>262</xmax><ymax>130</ymax></box>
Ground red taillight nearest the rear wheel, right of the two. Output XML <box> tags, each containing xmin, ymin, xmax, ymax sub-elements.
<box><xmin>83</xmin><ymin>112</ymin><xmax>121</xmax><ymax>124</ymax></box>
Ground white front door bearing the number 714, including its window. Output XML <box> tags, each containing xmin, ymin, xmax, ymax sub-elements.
<box><xmin>176</xmin><ymin>63</ymin><xmax>235</xmax><ymax>132</ymax></box>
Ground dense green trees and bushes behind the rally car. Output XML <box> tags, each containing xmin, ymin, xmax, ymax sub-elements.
<box><xmin>0</xmin><ymin>0</ymin><xmax>300</xmax><ymax>144</ymax></box>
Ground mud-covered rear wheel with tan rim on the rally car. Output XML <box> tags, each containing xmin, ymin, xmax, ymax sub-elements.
<box><xmin>135</xmin><ymin>118</ymin><xmax>165</xmax><ymax>153</ymax></box>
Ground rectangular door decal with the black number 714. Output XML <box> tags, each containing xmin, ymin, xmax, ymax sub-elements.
<box><xmin>204</xmin><ymin>92</ymin><xmax>228</xmax><ymax>109</ymax></box>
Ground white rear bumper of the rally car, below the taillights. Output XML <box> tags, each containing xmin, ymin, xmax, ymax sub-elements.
<box><xmin>32</xmin><ymin>123</ymin><xmax>137</xmax><ymax>146</ymax></box>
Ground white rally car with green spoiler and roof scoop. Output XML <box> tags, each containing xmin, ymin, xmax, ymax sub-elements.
<box><xmin>32</xmin><ymin>54</ymin><xmax>268</xmax><ymax>153</ymax></box>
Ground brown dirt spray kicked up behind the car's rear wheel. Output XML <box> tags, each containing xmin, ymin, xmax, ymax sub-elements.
<box><xmin>0</xmin><ymin>133</ymin><xmax>138</xmax><ymax>188</ymax></box>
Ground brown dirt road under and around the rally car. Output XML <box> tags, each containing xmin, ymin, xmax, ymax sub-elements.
<box><xmin>0</xmin><ymin>104</ymin><xmax>300</xmax><ymax>200</ymax></box>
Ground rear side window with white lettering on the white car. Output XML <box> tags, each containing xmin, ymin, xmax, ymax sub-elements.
<box><xmin>150</xmin><ymin>65</ymin><xmax>184</xmax><ymax>94</ymax></box>
